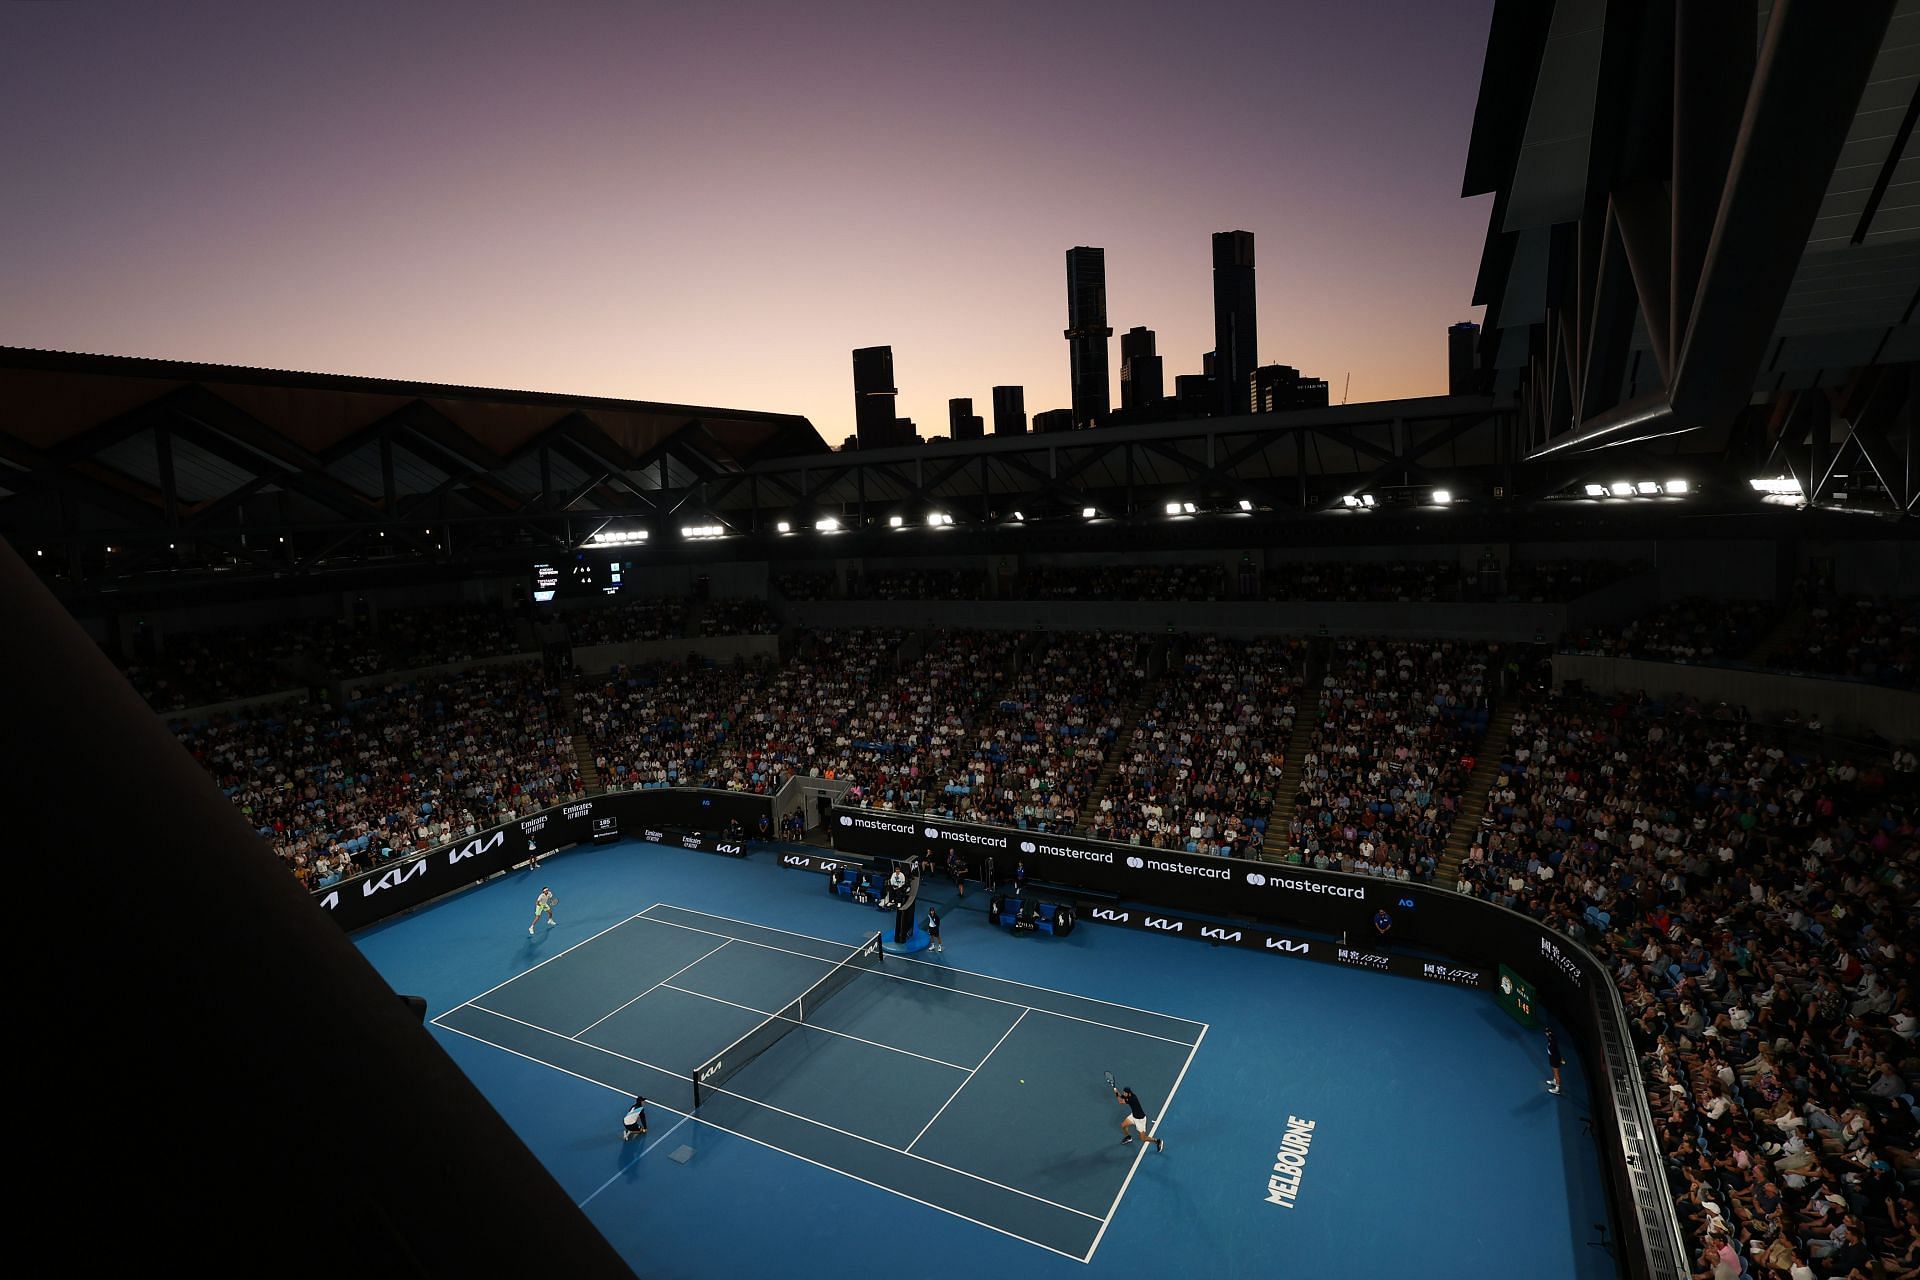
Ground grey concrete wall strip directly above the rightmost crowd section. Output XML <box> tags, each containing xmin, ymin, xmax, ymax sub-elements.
<box><xmin>1553</xmin><ymin>652</ymin><xmax>1920</xmax><ymax>743</ymax></box>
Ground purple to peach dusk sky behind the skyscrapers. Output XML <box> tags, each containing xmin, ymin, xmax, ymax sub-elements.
<box><xmin>0</xmin><ymin>0</ymin><xmax>1492</xmax><ymax>443</ymax></box>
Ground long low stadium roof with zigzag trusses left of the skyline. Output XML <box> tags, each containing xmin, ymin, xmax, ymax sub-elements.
<box><xmin>0</xmin><ymin>347</ymin><xmax>828</xmax><ymax>518</ymax></box>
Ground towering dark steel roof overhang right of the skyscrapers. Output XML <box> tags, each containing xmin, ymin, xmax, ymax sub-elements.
<box><xmin>1463</xmin><ymin>0</ymin><xmax>1920</xmax><ymax>507</ymax></box>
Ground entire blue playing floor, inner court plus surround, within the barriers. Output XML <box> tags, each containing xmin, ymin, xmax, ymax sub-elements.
<box><xmin>355</xmin><ymin>842</ymin><xmax>1615</xmax><ymax>1280</ymax></box>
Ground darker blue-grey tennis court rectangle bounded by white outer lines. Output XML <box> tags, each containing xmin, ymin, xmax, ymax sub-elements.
<box><xmin>434</xmin><ymin>904</ymin><xmax>1208</xmax><ymax>1261</ymax></box>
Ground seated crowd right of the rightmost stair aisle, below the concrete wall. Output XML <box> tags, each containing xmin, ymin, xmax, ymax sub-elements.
<box><xmin>1457</xmin><ymin>697</ymin><xmax>1920</xmax><ymax>1280</ymax></box>
